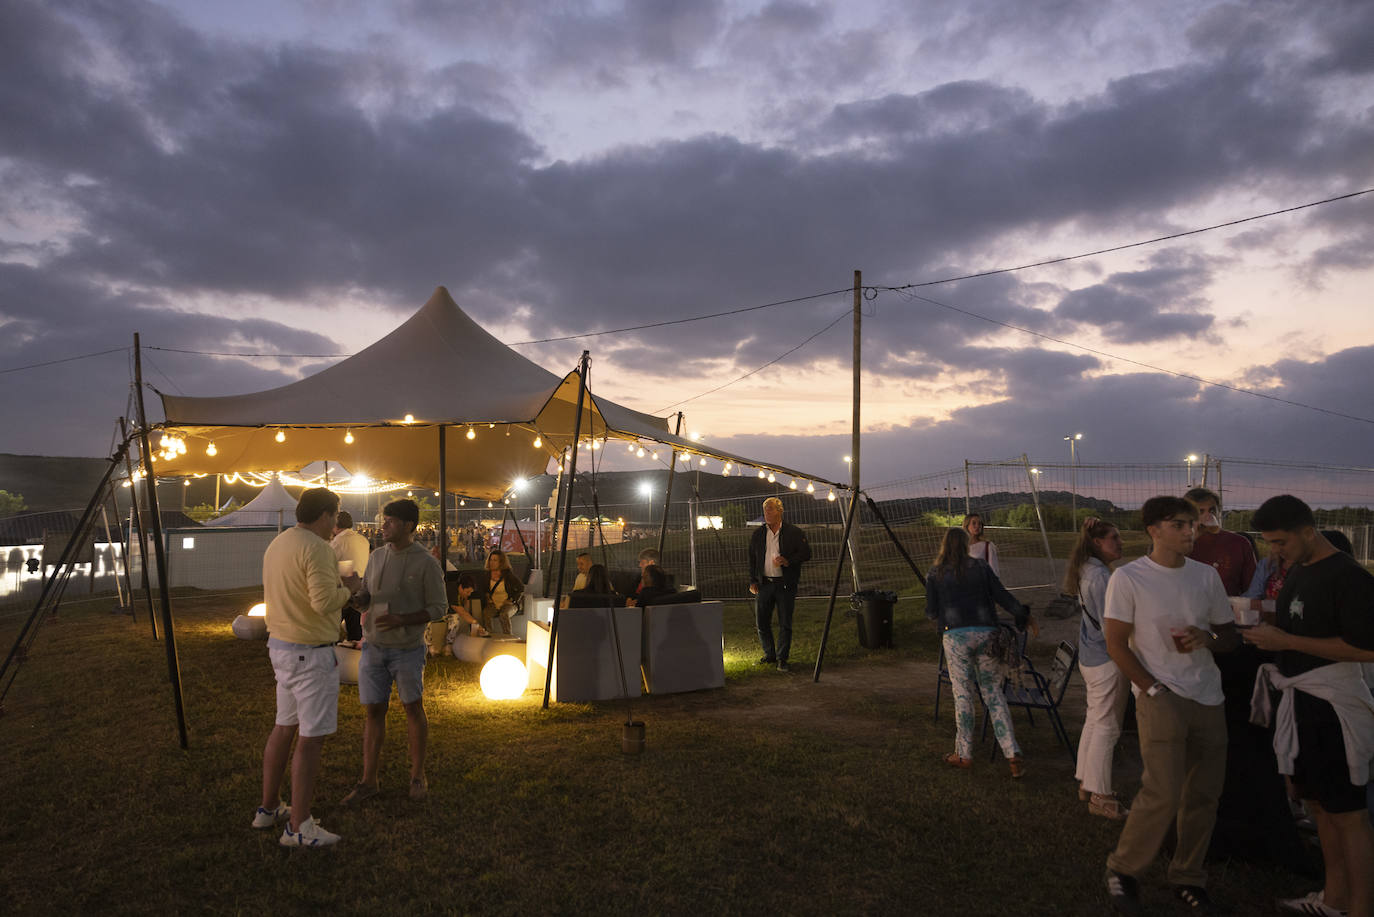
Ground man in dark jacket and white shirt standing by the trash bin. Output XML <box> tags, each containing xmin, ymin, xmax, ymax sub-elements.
<box><xmin>749</xmin><ymin>496</ymin><xmax>811</xmax><ymax>672</ymax></box>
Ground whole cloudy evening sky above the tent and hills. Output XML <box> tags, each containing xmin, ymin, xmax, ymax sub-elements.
<box><xmin>0</xmin><ymin>0</ymin><xmax>1374</xmax><ymax>484</ymax></box>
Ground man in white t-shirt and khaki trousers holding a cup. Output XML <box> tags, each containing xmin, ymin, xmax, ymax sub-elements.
<box><xmin>1102</xmin><ymin>496</ymin><xmax>1239</xmax><ymax>914</ymax></box>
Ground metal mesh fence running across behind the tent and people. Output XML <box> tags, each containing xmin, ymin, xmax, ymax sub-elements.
<box><xmin>0</xmin><ymin>456</ymin><xmax>1374</xmax><ymax>616</ymax></box>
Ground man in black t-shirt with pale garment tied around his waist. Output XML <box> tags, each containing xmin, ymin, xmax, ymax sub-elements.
<box><xmin>1245</xmin><ymin>494</ymin><xmax>1374</xmax><ymax>917</ymax></box>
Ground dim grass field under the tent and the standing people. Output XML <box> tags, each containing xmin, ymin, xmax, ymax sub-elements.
<box><xmin>0</xmin><ymin>595</ymin><xmax>1324</xmax><ymax>916</ymax></box>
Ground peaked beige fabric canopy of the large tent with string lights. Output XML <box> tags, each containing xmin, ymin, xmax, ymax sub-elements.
<box><xmin>154</xmin><ymin>287</ymin><xmax>840</xmax><ymax>499</ymax></box>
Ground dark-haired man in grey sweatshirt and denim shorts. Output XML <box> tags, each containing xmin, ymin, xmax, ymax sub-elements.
<box><xmin>344</xmin><ymin>500</ymin><xmax>448</xmax><ymax>806</ymax></box>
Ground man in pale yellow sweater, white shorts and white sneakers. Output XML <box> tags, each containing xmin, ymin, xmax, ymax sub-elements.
<box><xmin>253</xmin><ymin>487</ymin><xmax>363</xmax><ymax>847</ymax></box>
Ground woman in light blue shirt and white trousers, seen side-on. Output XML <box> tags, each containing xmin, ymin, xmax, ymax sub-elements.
<box><xmin>1063</xmin><ymin>516</ymin><xmax>1131</xmax><ymax>821</ymax></box>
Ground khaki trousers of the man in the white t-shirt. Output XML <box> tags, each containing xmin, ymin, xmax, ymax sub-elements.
<box><xmin>1107</xmin><ymin>692</ymin><xmax>1226</xmax><ymax>885</ymax></box>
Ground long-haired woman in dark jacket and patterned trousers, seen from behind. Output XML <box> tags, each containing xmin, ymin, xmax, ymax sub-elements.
<box><xmin>926</xmin><ymin>528</ymin><xmax>1040</xmax><ymax>777</ymax></box>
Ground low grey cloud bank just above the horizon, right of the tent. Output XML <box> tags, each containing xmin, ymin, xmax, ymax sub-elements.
<box><xmin>720</xmin><ymin>346</ymin><xmax>1374</xmax><ymax>487</ymax></box>
